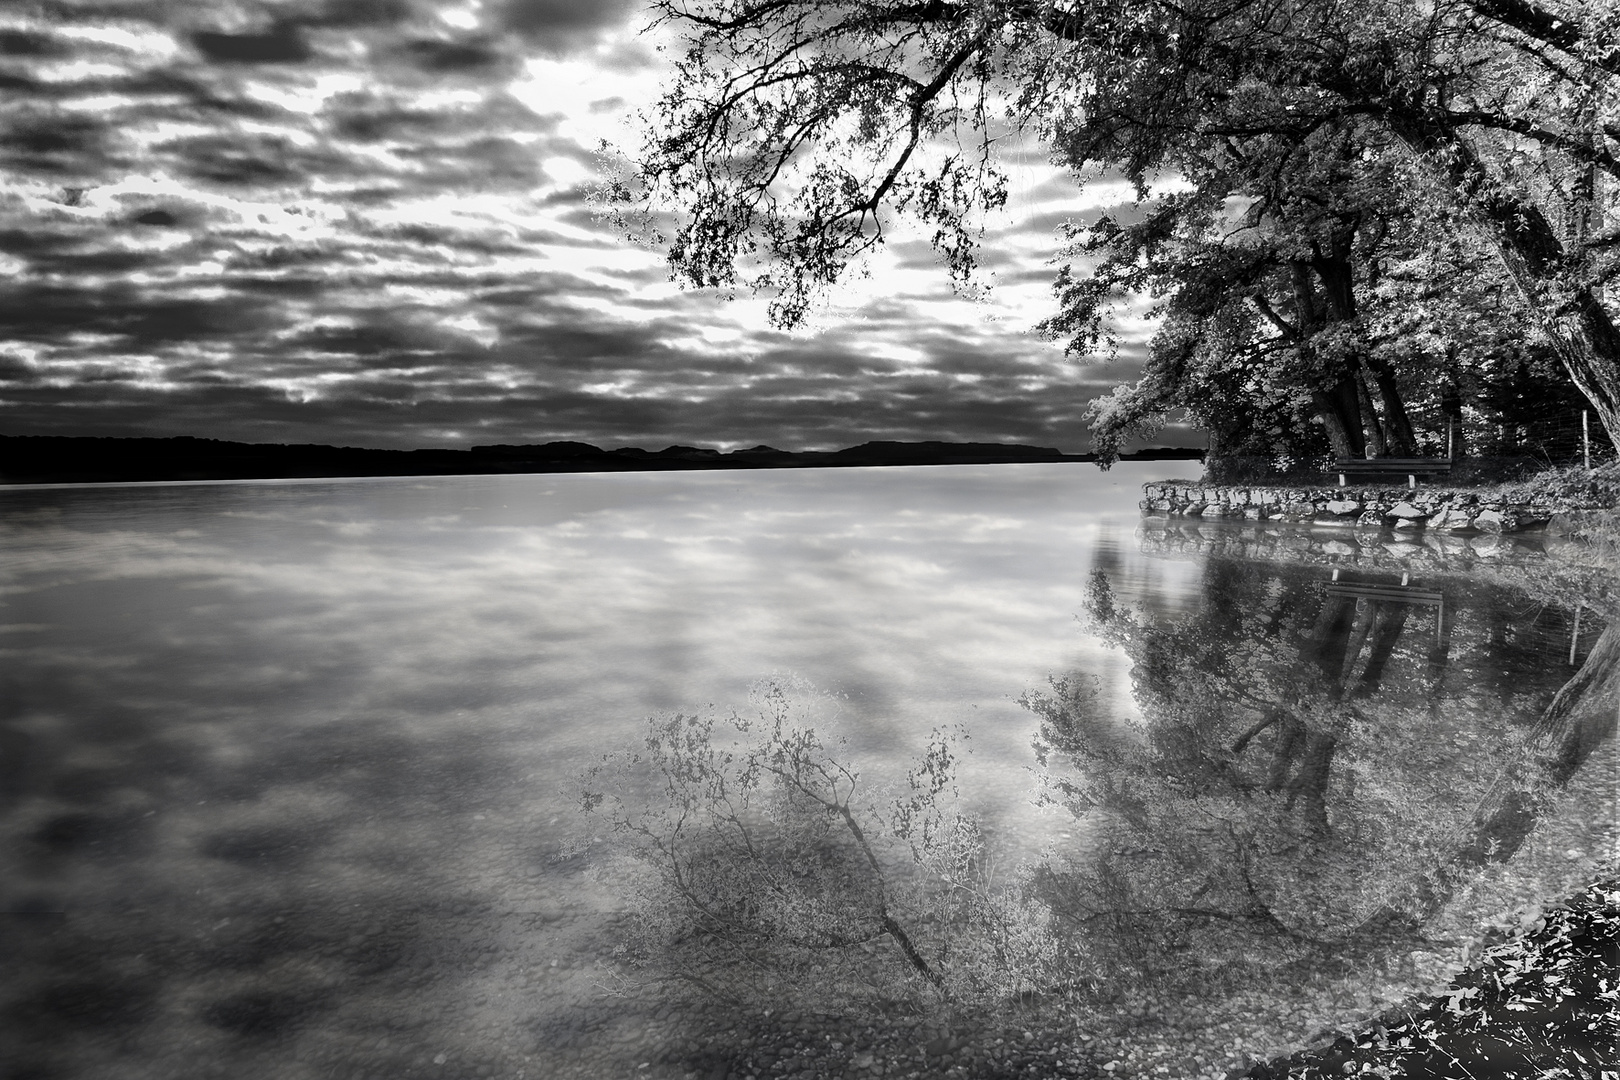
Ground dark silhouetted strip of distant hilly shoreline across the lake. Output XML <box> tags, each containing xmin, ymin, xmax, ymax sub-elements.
<box><xmin>0</xmin><ymin>436</ymin><xmax>1204</xmax><ymax>484</ymax></box>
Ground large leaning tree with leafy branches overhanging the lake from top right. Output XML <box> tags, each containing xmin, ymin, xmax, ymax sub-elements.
<box><xmin>625</xmin><ymin>0</ymin><xmax>1620</xmax><ymax>450</ymax></box>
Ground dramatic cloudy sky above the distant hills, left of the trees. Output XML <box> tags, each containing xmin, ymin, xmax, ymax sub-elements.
<box><xmin>0</xmin><ymin>0</ymin><xmax>1166</xmax><ymax>450</ymax></box>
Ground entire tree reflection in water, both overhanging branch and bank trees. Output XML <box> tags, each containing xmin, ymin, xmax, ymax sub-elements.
<box><xmin>586</xmin><ymin>527</ymin><xmax>1620</xmax><ymax>1062</ymax></box>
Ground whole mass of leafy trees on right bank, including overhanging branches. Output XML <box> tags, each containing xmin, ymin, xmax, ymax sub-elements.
<box><xmin>611</xmin><ymin>0</ymin><xmax>1620</xmax><ymax>461</ymax></box>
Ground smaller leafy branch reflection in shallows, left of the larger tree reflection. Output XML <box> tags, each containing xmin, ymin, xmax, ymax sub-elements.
<box><xmin>582</xmin><ymin>680</ymin><xmax>1082</xmax><ymax>1001</ymax></box>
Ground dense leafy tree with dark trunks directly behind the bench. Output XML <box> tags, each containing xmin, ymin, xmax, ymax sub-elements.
<box><xmin>1043</xmin><ymin>118</ymin><xmax>1416</xmax><ymax>461</ymax></box>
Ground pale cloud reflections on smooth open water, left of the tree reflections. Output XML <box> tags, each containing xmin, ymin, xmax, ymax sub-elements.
<box><xmin>0</xmin><ymin>465</ymin><xmax>1162</xmax><ymax>1075</ymax></box>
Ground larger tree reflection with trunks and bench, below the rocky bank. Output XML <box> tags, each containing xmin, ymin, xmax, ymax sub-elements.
<box><xmin>1025</xmin><ymin>531</ymin><xmax>1620</xmax><ymax>991</ymax></box>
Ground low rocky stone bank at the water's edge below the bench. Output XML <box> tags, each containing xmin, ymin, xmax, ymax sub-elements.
<box><xmin>1139</xmin><ymin>481</ymin><xmax>1620</xmax><ymax>536</ymax></box>
